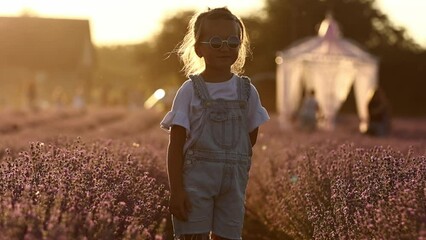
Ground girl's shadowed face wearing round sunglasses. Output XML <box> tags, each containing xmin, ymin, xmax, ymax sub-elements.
<box><xmin>195</xmin><ymin>19</ymin><xmax>240</xmax><ymax>72</ymax></box>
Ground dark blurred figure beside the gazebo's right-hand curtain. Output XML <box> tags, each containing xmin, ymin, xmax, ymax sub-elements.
<box><xmin>366</xmin><ymin>88</ymin><xmax>391</xmax><ymax>137</ymax></box>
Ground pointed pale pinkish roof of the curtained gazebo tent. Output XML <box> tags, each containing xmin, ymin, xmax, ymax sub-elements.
<box><xmin>277</xmin><ymin>15</ymin><xmax>377</xmax><ymax>63</ymax></box>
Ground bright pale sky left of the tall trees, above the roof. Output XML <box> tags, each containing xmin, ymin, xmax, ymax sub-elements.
<box><xmin>0</xmin><ymin>0</ymin><xmax>263</xmax><ymax>45</ymax></box>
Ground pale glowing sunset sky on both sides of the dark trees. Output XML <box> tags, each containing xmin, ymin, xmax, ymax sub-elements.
<box><xmin>0</xmin><ymin>0</ymin><xmax>426</xmax><ymax>47</ymax></box>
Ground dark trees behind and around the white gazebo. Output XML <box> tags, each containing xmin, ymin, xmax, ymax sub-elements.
<box><xmin>247</xmin><ymin>0</ymin><xmax>426</xmax><ymax>115</ymax></box>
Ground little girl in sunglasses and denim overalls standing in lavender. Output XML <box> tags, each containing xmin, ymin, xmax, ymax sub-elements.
<box><xmin>161</xmin><ymin>8</ymin><xmax>269</xmax><ymax>239</ymax></box>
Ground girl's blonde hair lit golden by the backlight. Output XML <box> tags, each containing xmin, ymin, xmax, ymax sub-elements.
<box><xmin>177</xmin><ymin>7</ymin><xmax>251</xmax><ymax>76</ymax></box>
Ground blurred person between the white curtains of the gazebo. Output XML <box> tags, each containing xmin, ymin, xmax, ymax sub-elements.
<box><xmin>299</xmin><ymin>90</ymin><xmax>319</xmax><ymax>132</ymax></box>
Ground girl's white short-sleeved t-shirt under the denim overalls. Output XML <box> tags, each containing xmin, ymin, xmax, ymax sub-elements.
<box><xmin>160</xmin><ymin>75</ymin><xmax>269</xmax><ymax>151</ymax></box>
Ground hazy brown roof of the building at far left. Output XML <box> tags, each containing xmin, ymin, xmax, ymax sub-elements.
<box><xmin>0</xmin><ymin>17</ymin><xmax>93</xmax><ymax>70</ymax></box>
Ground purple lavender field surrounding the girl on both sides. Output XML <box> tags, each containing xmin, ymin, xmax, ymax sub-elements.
<box><xmin>0</xmin><ymin>108</ymin><xmax>426</xmax><ymax>240</ymax></box>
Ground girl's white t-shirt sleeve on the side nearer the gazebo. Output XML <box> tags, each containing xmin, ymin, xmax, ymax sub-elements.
<box><xmin>248</xmin><ymin>84</ymin><xmax>269</xmax><ymax>132</ymax></box>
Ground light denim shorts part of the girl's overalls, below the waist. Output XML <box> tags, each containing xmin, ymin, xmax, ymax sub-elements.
<box><xmin>173</xmin><ymin>154</ymin><xmax>250</xmax><ymax>239</ymax></box>
